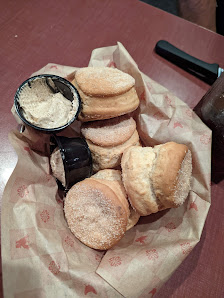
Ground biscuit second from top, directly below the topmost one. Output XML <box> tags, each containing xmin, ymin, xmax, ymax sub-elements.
<box><xmin>81</xmin><ymin>115</ymin><xmax>140</xmax><ymax>172</ymax></box>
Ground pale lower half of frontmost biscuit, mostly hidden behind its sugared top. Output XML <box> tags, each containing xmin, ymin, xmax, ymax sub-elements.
<box><xmin>91</xmin><ymin>169</ymin><xmax>140</xmax><ymax>230</ymax></box>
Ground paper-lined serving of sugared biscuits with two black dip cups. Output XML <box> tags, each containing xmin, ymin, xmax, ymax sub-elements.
<box><xmin>3</xmin><ymin>43</ymin><xmax>211</xmax><ymax>297</ymax></box>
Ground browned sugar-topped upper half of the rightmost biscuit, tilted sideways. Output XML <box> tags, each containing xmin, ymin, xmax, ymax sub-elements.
<box><xmin>152</xmin><ymin>142</ymin><xmax>192</xmax><ymax>208</ymax></box>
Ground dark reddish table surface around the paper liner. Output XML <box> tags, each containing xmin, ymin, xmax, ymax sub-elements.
<box><xmin>0</xmin><ymin>0</ymin><xmax>224</xmax><ymax>297</ymax></box>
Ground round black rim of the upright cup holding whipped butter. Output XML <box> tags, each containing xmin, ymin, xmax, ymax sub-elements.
<box><xmin>14</xmin><ymin>74</ymin><xmax>81</xmax><ymax>133</ymax></box>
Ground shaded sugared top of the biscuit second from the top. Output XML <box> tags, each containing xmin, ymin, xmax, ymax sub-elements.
<box><xmin>81</xmin><ymin>115</ymin><xmax>136</xmax><ymax>147</ymax></box>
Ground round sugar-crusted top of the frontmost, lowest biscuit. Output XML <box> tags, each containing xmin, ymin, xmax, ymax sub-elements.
<box><xmin>64</xmin><ymin>178</ymin><xmax>127</xmax><ymax>250</ymax></box>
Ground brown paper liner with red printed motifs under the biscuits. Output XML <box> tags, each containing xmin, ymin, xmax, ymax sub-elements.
<box><xmin>2</xmin><ymin>43</ymin><xmax>211</xmax><ymax>298</ymax></box>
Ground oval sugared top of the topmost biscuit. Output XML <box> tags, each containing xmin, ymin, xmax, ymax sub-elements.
<box><xmin>75</xmin><ymin>67</ymin><xmax>135</xmax><ymax>97</ymax></box>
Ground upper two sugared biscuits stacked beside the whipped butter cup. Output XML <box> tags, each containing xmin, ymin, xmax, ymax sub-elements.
<box><xmin>72</xmin><ymin>67</ymin><xmax>139</xmax><ymax>172</ymax></box>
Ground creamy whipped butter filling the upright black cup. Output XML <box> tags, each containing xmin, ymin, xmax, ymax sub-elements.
<box><xmin>19</xmin><ymin>78</ymin><xmax>79</xmax><ymax>128</ymax></box>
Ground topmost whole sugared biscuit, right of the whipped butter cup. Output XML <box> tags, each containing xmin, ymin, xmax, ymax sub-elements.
<box><xmin>72</xmin><ymin>67</ymin><xmax>139</xmax><ymax>121</ymax></box>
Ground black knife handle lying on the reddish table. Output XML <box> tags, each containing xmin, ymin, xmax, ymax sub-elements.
<box><xmin>155</xmin><ymin>40</ymin><xmax>224</xmax><ymax>85</ymax></box>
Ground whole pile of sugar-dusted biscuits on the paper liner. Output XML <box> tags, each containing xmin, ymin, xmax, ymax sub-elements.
<box><xmin>64</xmin><ymin>67</ymin><xmax>192</xmax><ymax>250</ymax></box>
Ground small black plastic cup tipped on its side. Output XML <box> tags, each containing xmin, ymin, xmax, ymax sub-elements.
<box><xmin>50</xmin><ymin>135</ymin><xmax>92</xmax><ymax>191</ymax></box>
